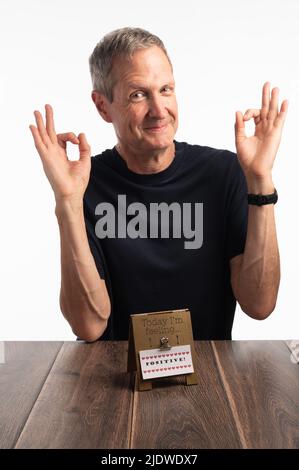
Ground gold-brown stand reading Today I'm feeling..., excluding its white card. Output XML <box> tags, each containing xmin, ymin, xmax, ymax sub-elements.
<box><xmin>127</xmin><ymin>309</ymin><xmax>197</xmax><ymax>391</ymax></box>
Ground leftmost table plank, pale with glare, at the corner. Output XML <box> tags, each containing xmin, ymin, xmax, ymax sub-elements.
<box><xmin>0</xmin><ymin>341</ymin><xmax>63</xmax><ymax>449</ymax></box>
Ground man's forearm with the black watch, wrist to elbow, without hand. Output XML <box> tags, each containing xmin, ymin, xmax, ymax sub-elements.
<box><xmin>237</xmin><ymin>181</ymin><xmax>280</xmax><ymax>319</ymax></box>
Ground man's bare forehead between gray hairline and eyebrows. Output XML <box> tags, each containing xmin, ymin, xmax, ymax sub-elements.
<box><xmin>113</xmin><ymin>46</ymin><xmax>173</xmax><ymax>88</ymax></box>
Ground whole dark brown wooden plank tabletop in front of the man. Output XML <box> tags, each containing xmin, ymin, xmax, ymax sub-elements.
<box><xmin>0</xmin><ymin>341</ymin><xmax>299</xmax><ymax>449</ymax></box>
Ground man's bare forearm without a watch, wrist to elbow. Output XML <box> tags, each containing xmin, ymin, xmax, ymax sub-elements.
<box><xmin>55</xmin><ymin>203</ymin><xmax>110</xmax><ymax>341</ymax></box>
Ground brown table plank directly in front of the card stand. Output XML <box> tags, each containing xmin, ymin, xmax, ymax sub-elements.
<box><xmin>131</xmin><ymin>341</ymin><xmax>242</xmax><ymax>449</ymax></box>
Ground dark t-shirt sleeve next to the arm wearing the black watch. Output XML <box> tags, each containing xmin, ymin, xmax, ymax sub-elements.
<box><xmin>226</xmin><ymin>154</ymin><xmax>248</xmax><ymax>259</ymax></box>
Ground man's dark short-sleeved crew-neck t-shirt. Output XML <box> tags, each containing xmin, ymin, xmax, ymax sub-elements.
<box><xmin>84</xmin><ymin>141</ymin><xmax>248</xmax><ymax>340</ymax></box>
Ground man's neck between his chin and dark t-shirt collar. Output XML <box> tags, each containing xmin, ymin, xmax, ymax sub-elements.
<box><xmin>116</xmin><ymin>142</ymin><xmax>175</xmax><ymax>174</ymax></box>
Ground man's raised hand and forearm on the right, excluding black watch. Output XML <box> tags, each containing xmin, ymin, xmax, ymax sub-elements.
<box><xmin>230</xmin><ymin>82</ymin><xmax>288</xmax><ymax>319</ymax></box>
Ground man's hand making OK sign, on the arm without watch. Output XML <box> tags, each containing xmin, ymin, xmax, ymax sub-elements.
<box><xmin>29</xmin><ymin>104</ymin><xmax>91</xmax><ymax>207</ymax></box>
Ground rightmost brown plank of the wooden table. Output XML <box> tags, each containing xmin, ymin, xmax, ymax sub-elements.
<box><xmin>212</xmin><ymin>341</ymin><xmax>299</xmax><ymax>449</ymax></box>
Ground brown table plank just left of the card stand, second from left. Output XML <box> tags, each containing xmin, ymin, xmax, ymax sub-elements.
<box><xmin>16</xmin><ymin>341</ymin><xmax>133</xmax><ymax>449</ymax></box>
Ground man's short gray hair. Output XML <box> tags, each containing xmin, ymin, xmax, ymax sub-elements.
<box><xmin>89</xmin><ymin>27</ymin><xmax>172</xmax><ymax>103</ymax></box>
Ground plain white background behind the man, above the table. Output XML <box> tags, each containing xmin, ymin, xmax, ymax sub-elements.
<box><xmin>0</xmin><ymin>0</ymin><xmax>299</xmax><ymax>340</ymax></box>
